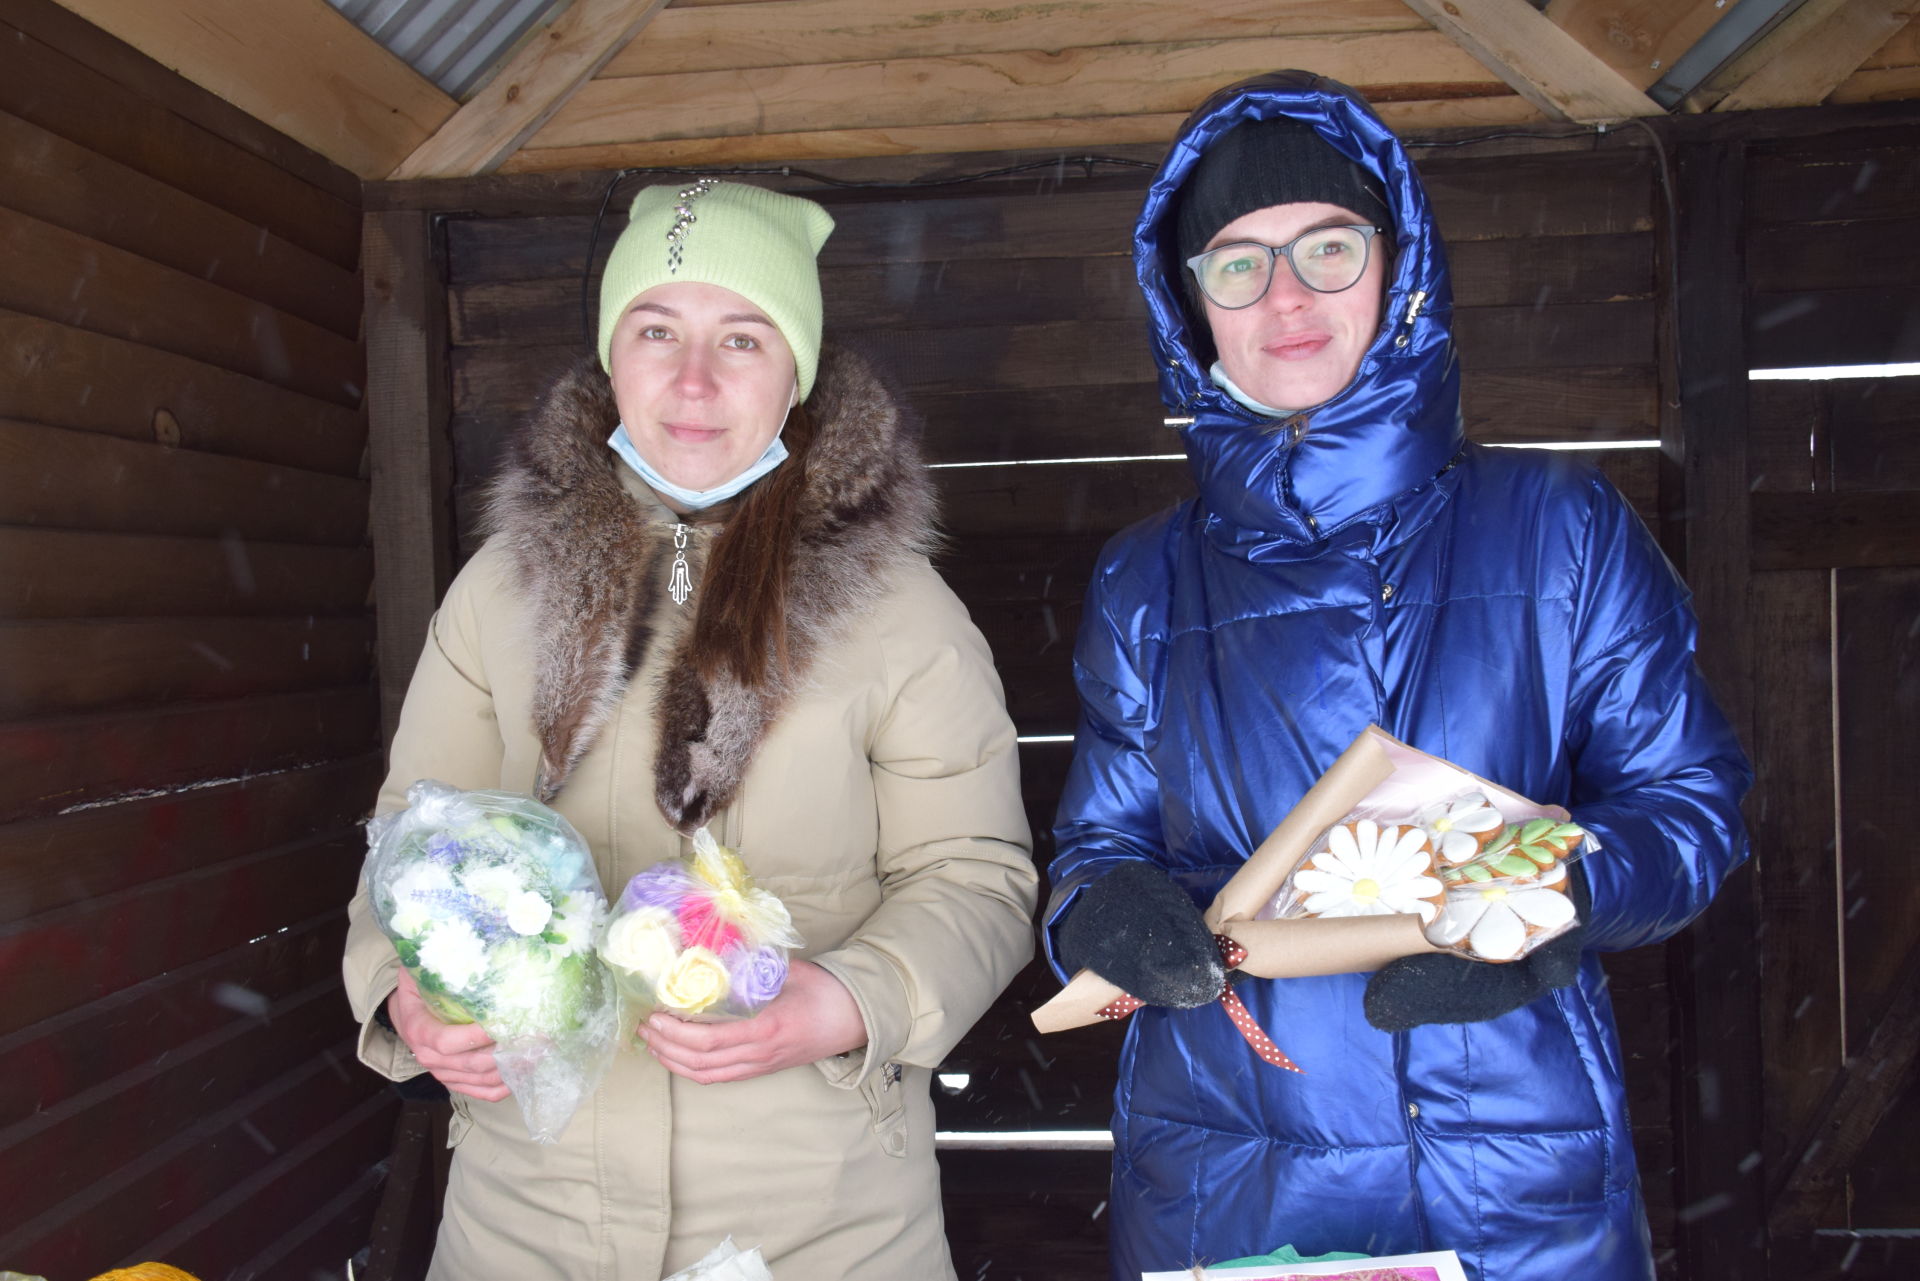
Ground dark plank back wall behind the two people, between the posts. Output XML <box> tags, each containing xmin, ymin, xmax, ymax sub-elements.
<box><xmin>408</xmin><ymin>127</ymin><xmax>1674</xmax><ymax>1277</ymax></box>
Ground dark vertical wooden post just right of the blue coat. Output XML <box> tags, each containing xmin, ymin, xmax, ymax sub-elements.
<box><xmin>1647</xmin><ymin>130</ymin><xmax>1766</xmax><ymax>1277</ymax></box>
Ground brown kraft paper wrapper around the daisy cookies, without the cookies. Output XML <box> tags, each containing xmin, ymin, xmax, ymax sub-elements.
<box><xmin>1031</xmin><ymin>726</ymin><xmax>1567</xmax><ymax>1031</ymax></box>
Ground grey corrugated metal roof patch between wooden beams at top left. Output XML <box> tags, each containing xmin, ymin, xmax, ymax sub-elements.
<box><xmin>326</xmin><ymin>0</ymin><xmax>568</xmax><ymax>100</ymax></box>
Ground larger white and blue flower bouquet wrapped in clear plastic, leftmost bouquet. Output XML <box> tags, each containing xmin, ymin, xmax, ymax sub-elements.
<box><xmin>367</xmin><ymin>780</ymin><xmax>616</xmax><ymax>1143</ymax></box>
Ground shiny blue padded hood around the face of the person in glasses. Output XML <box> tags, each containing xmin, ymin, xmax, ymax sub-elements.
<box><xmin>1133</xmin><ymin>71</ymin><xmax>1463</xmax><ymax>545</ymax></box>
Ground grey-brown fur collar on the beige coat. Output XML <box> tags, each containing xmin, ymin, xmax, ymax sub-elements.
<box><xmin>476</xmin><ymin>348</ymin><xmax>933</xmax><ymax>832</ymax></box>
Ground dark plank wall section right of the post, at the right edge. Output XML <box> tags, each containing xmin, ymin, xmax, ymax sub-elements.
<box><xmin>1745</xmin><ymin>120</ymin><xmax>1920</xmax><ymax>1275</ymax></box>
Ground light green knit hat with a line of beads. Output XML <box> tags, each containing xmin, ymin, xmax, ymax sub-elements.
<box><xmin>599</xmin><ymin>179</ymin><xmax>833</xmax><ymax>399</ymax></box>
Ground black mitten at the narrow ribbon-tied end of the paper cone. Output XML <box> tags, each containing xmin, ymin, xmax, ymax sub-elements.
<box><xmin>1058</xmin><ymin>862</ymin><xmax>1227</xmax><ymax>1010</ymax></box>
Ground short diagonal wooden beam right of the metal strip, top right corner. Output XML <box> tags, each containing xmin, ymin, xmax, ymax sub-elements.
<box><xmin>1709</xmin><ymin>0</ymin><xmax>1912</xmax><ymax>111</ymax></box>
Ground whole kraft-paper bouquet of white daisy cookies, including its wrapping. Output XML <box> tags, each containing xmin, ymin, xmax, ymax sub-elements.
<box><xmin>1033</xmin><ymin>726</ymin><xmax>1597</xmax><ymax>1041</ymax></box>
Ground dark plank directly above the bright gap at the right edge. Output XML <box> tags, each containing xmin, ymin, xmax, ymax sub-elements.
<box><xmin>1745</xmin><ymin>284</ymin><xmax>1920</xmax><ymax>369</ymax></box>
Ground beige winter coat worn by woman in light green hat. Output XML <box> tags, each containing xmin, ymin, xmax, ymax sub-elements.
<box><xmin>346</xmin><ymin>357</ymin><xmax>1035</xmax><ymax>1281</ymax></box>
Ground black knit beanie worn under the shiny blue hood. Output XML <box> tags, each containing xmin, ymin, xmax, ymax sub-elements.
<box><xmin>1173</xmin><ymin>117</ymin><xmax>1394</xmax><ymax>265</ymax></box>
